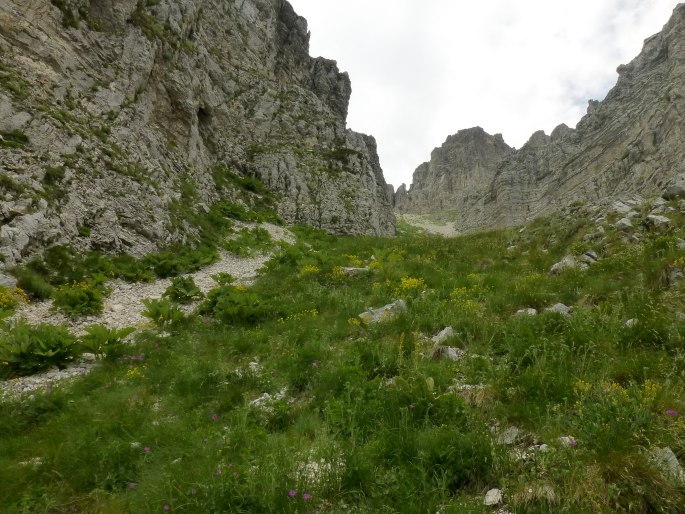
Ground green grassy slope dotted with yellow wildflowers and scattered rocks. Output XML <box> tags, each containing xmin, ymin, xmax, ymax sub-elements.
<box><xmin>0</xmin><ymin>202</ymin><xmax>685</xmax><ymax>513</ymax></box>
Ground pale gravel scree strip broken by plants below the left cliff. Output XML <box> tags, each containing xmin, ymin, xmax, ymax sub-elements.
<box><xmin>0</xmin><ymin>223</ymin><xmax>295</xmax><ymax>397</ymax></box>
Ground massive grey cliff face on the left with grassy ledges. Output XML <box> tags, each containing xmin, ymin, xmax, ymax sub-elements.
<box><xmin>0</xmin><ymin>0</ymin><xmax>394</xmax><ymax>265</ymax></box>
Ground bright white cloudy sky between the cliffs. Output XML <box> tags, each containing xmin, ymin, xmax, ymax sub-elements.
<box><xmin>289</xmin><ymin>0</ymin><xmax>678</xmax><ymax>188</ymax></box>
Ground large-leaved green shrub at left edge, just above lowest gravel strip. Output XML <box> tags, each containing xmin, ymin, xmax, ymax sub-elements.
<box><xmin>0</xmin><ymin>321</ymin><xmax>78</xmax><ymax>376</ymax></box>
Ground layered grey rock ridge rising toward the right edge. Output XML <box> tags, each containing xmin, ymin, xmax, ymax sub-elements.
<box><xmin>396</xmin><ymin>4</ymin><xmax>685</xmax><ymax>230</ymax></box>
